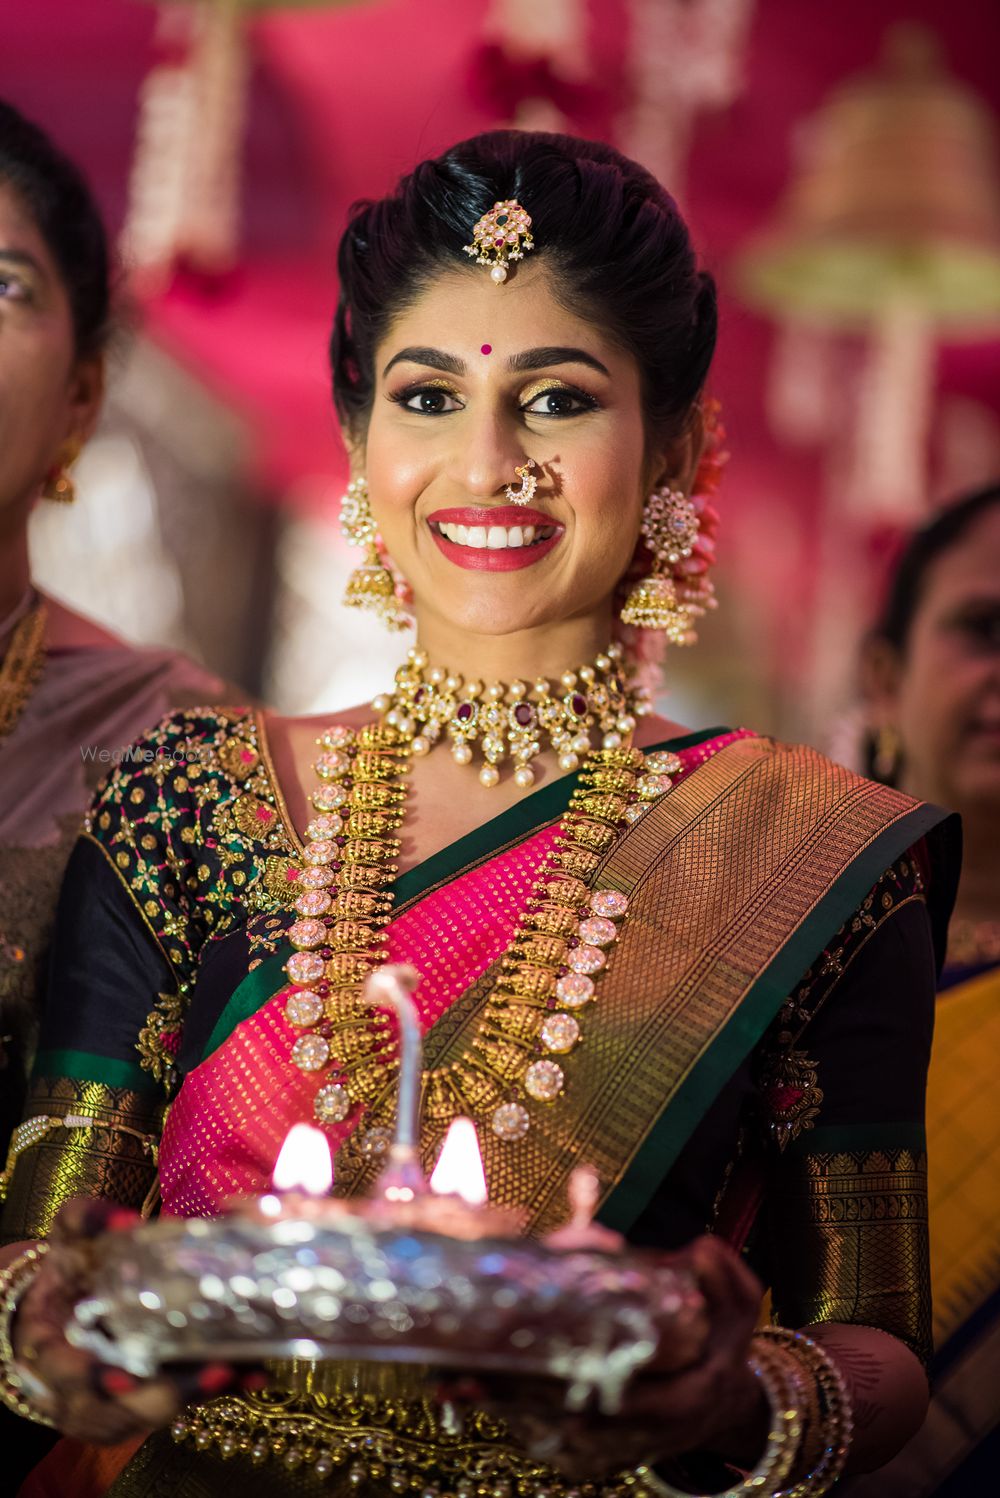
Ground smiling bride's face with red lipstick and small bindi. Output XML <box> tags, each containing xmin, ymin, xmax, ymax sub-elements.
<box><xmin>356</xmin><ymin>262</ymin><xmax>659</xmax><ymax>635</ymax></box>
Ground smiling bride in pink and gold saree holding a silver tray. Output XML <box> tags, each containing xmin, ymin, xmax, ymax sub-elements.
<box><xmin>0</xmin><ymin>132</ymin><xmax>955</xmax><ymax>1498</ymax></box>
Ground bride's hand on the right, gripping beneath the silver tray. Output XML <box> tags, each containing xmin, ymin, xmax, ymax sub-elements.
<box><xmin>442</xmin><ymin>1237</ymin><xmax>768</xmax><ymax>1482</ymax></box>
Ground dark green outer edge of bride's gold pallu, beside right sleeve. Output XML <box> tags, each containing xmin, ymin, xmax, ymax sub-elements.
<box><xmin>597</xmin><ymin>804</ymin><xmax>949</xmax><ymax>1233</ymax></box>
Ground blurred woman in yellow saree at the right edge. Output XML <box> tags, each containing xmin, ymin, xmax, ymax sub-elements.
<box><xmin>852</xmin><ymin>484</ymin><xmax>1000</xmax><ymax>1498</ymax></box>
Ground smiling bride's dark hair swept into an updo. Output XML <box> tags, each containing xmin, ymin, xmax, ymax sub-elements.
<box><xmin>329</xmin><ymin>130</ymin><xmax>717</xmax><ymax>440</ymax></box>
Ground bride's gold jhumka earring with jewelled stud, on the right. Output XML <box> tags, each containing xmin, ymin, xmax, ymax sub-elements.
<box><xmin>621</xmin><ymin>487</ymin><xmax>713</xmax><ymax>646</ymax></box>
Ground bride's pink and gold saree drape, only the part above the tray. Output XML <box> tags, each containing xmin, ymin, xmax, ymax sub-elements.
<box><xmin>160</xmin><ymin>736</ymin><xmax>940</xmax><ymax>1233</ymax></box>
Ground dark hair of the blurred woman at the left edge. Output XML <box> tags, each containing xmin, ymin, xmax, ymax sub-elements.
<box><xmin>0</xmin><ymin>99</ymin><xmax>111</xmax><ymax>358</ymax></box>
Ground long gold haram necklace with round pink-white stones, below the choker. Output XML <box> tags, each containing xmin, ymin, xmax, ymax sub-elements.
<box><xmin>283</xmin><ymin>658</ymin><xmax>680</xmax><ymax>1158</ymax></box>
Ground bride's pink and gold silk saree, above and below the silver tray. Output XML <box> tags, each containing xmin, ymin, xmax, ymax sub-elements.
<box><xmin>15</xmin><ymin>734</ymin><xmax>942</xmax><ymax>1498</ymax></box>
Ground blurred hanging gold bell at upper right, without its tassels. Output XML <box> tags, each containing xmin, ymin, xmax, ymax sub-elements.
<box><xmin>738</xmin><ymin>24</ymin><xmax>1000</xmax><ymax>339</ymax></box>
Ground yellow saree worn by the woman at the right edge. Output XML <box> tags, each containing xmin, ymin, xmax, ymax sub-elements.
<box><xmin>850</xmin><ymin>968</ymin><xmax>1000</xmax><ymax>1498</ymax></box>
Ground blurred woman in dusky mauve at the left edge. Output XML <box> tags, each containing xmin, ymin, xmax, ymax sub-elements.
<box><xmin>0</xmin><ymin>102</ymin><xmax>223</xmax><ymax>1152</ymax></box>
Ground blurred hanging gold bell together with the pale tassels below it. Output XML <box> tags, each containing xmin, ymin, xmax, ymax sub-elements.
<box><xmin>738</xmin><ymin>24</ymin><xmax>1000</xmax><ymax>523</ymax></box>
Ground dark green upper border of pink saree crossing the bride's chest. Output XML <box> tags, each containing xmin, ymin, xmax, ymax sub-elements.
<box><xmin>201</xmin><ymin>728</ymin><xmax>732</xmax><ymax>1061</ymax></box>
